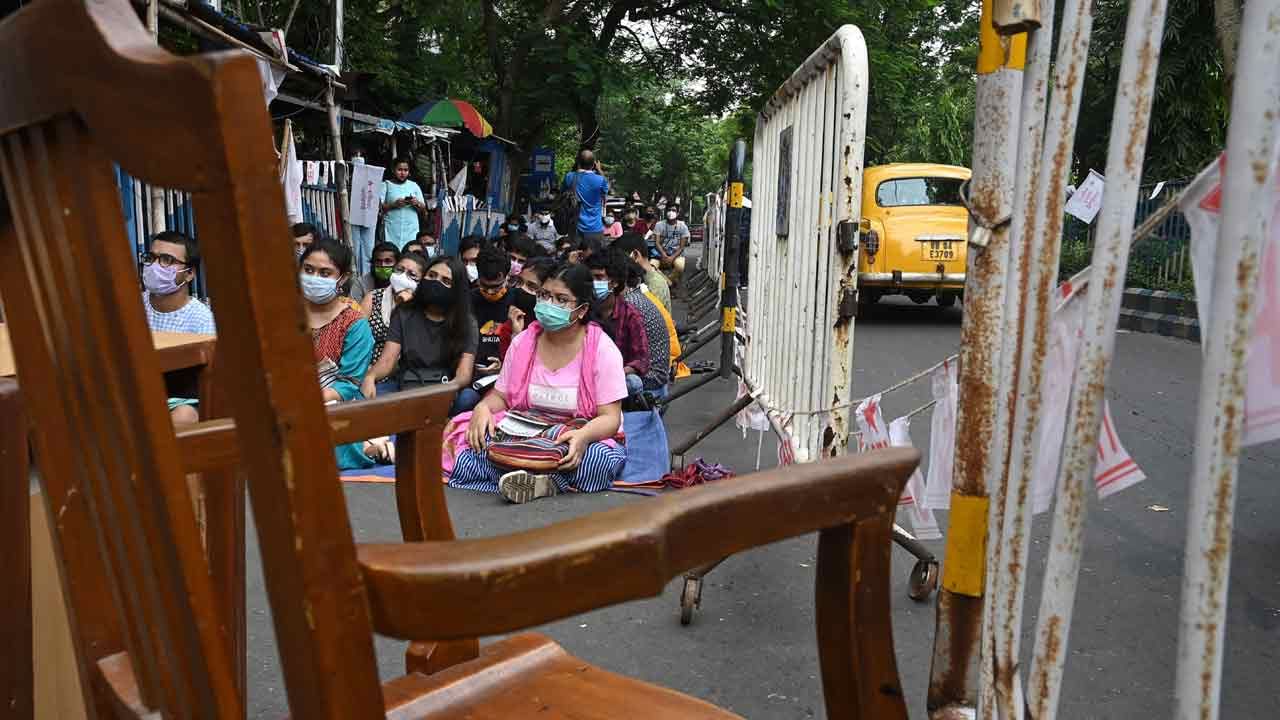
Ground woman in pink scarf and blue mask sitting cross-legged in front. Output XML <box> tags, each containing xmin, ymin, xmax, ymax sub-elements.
<box><xmin>449</xmin><ymin>264</ymin><xmax>627</xmax><ymax>502</ymax></box>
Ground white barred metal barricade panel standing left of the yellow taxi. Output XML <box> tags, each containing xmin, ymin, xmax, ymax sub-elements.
<box><xmin>742</xmin><ymin>26</ymin><xmax>868</xmax><ymax>462</ymax></box>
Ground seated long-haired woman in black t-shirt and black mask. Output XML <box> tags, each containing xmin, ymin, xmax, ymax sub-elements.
<box><xmin>361</xmin><ymin>256</ymin><xmax>480</xmax><ymax>415</ymax></box>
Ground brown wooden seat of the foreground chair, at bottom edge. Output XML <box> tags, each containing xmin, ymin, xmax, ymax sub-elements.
<box><xmin>383</xmin><ymin>633</ymin><xmax>741</xmax><ymax>720</ymax></box>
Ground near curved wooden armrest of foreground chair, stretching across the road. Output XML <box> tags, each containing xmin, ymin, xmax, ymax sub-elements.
<box><xmin>357</xmin><ymin>448</ymin><xmax>920</xmax><ymax>641</ymax></box>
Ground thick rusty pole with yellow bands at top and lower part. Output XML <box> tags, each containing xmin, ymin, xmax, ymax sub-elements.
<box><xmin>928</xmin><ymin>0</ymin><xmax>1025</xmax><ymax>719</ymax></box>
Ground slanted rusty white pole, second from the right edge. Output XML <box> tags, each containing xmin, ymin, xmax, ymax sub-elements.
<box><xmin>1021</xmin><ymin>0</ymin><xmax>1166</xmax><ymax>720</ymax></box>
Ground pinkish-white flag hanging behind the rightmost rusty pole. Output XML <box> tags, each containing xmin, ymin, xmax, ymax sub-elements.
<box><xmin>1179</xmin><ymin>155</ymin><xmax>1280</xmax><ymax>446</ymax></box>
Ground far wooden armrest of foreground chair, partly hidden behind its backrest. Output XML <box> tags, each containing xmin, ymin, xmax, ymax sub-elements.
<box><xmin>178</xmin><ymin>383</ymin><xmax>458</xmax><ymax>473</ymax></box>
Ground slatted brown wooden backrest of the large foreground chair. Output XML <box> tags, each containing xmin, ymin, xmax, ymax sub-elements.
<box><xmin>0</xmin><ymin>0</ymin><xmax>381</xmax><ymax>719</ymax></box>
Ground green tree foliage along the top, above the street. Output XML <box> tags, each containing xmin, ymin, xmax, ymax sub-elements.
<box><xmin>145</xmin><ymin>0</ymin><xmax>1238</xmax><ymax>195</ymax></box>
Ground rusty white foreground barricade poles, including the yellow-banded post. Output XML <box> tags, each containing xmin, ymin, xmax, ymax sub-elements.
<box><xmin>928</xmin><ymin>0</ymin><xmax>1280</xmax><ymax>720</ymax></box>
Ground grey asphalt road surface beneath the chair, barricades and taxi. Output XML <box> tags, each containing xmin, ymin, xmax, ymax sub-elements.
<box><xmin>241</xmin><ymin>289</ymin><xmax>1280</xmax><ymax>719</ymax></box>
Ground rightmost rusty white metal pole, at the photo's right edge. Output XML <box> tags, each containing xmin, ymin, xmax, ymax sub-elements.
<box><xmin>1174</xmin><ymin>0</ymin><xmax>1280</xmax><ymax>720</ymax></box>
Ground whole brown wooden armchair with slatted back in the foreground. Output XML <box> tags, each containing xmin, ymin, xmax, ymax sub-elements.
<box><xmin>0</xmin><ymin>0</ymin><xmax>918</xmax><ymax>720</ymax></box>
